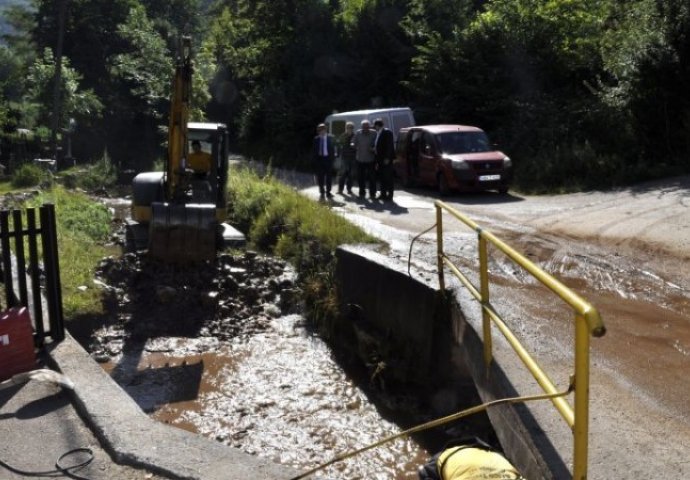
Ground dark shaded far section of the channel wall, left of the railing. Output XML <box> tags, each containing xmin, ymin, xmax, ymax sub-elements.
<box><xmin>336</xmin><ymin>246</ymin><xmax>448</xmax><ymax>382</ymax></box>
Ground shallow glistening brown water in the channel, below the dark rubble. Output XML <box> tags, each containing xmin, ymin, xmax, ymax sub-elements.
<box><xmin>104</xmin><ymin>315</ymin><xmax>452</xmax><ymax>480</ymax></box>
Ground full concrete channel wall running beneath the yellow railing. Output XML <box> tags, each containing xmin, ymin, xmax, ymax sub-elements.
<box><xmin>336</xmin><ymin>246</ymin><xmax>571</xmax><ymax>480</ymax></box>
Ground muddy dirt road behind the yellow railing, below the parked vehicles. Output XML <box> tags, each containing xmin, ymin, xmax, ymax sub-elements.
<box><xmin>293</xmin><ymin>172</ymin><xmax>690</xmax><ymax>479</ymax></box>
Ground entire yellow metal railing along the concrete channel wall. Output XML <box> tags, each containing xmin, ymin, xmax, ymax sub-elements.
<box><xmin>435</xmin><ymin>201</ymin><xmax>606</xmax><ymax>480</ymax></box>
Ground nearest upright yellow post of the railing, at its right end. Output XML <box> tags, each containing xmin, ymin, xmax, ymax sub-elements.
<box><xmin>573</xmin><ymin>314</ymin><xmax>589</xmax><ymax>480</ymax></box>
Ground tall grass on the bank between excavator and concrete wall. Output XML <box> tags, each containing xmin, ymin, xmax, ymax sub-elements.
<box><xmin>229</xmin><ymin>168</ymin><xmax>378</xmax><ymax>334</ymax></box>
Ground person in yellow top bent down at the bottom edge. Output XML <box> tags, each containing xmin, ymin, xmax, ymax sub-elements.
<box><xmin>419</xmin><ymin>442</ymin><xmax>526</xmax><ymax>480</ymax></box>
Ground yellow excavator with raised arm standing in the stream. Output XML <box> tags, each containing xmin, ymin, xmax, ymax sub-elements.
<box><xmin>127</xmin><ymin>37</ymin><xmax>245</xmax><ymax>263</ymax></box>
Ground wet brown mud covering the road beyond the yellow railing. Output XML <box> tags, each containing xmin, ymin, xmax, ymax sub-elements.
<box><xmin>440</xmin><ymin>228</ymin><xmax>690</xmax><ymax>424</ymax></box>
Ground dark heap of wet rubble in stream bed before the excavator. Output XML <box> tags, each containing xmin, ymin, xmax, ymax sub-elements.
<box><xmin>91</xmin><ymin>227</ymin><xmax>300</xmax><ymax>346</ymax></box>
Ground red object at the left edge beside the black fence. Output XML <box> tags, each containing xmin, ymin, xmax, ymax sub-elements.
<box><xmin>0</xmin><ymin>307</ymin><xmax>36</xmax><ymax>381</ymax></box>
